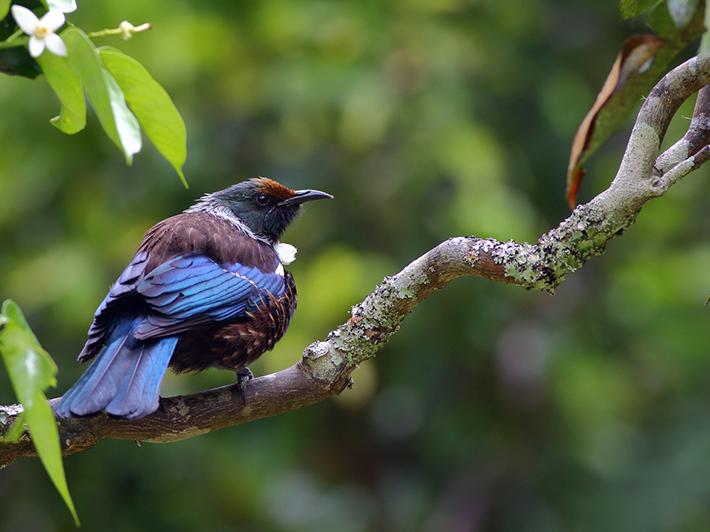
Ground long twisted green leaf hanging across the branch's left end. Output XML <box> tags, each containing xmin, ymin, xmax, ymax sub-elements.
<box><xmin>0</xmin><ymin>300</ymin><xmax>79</xmax><ymax>526</ymax></box>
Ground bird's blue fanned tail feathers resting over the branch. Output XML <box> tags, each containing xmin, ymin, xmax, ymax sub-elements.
<box><xmin>55</xmin><ymin>318</ymin><xmax>177</xmax><ymax>419</ymax></box>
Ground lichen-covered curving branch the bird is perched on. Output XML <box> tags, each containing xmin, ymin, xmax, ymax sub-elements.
<box><xmin>0</xmin><ymin>57</ymin><xmax>710</xmax><ymax>467</ymax></box>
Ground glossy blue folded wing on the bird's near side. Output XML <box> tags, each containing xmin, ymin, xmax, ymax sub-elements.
<box><xmin>135</xmin><ymin>255</ymin><xmax>285</xmax><ymax>340</ymax></box>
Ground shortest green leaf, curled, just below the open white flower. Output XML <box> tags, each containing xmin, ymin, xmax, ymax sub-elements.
<box><xmin>37</xmin><ymin>54</ymin><xmax>86</xmax><ymax>135</ymax></box>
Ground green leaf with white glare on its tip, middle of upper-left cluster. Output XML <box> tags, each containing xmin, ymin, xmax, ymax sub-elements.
<box><xmin>62</xmin><ymin>27</ymin><xmax>141</xmax><ymax>164</ymax></box>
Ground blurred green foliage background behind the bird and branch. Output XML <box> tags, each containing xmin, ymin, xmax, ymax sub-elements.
<box><xmin>0</xmin><ymin>0</ymin><xmax>710</xmax><ymax>532</ymax></box>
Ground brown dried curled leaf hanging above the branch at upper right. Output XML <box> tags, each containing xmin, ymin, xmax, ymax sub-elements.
<box><xmin>567</xmin><ymin>33</ymin><xmax>664</xmax><ymax>209</ymax></box>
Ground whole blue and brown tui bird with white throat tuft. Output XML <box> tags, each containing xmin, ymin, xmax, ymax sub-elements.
<box><xmin>55</xmin><ymin>178</ymin><xmax>333</xmax><ymax>419</ymax></box>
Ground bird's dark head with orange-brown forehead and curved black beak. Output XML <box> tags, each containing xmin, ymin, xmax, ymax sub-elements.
<box><xmin>196</xmin><ymin>177</ymin><xmax>333</xmax><ymax>242</ymax></box>
